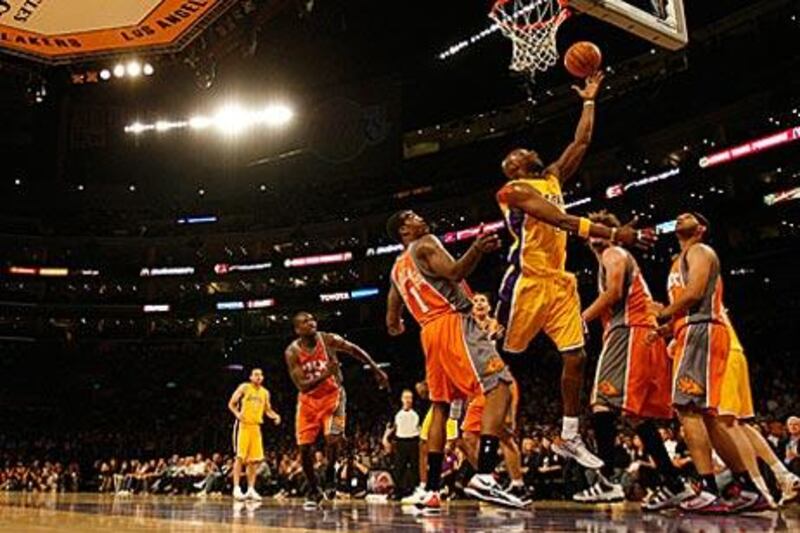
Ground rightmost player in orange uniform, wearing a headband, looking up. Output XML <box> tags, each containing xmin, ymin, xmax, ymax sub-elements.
<box><xmin>651</xmin><ymin>213</ymin><xmax>775</xmax><ymax>513</ymax></box>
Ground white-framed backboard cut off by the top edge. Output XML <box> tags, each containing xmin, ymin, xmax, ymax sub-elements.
<box><xmin>567</xmin><ymin>0</ymin><xmax>689</xmax><ymax>50</ymax></box>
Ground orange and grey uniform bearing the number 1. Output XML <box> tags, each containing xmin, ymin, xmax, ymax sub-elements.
<box><xmin>391</xmin><ymin>237</ymin><xmax>511</xmax><ymax>403</ymax></box>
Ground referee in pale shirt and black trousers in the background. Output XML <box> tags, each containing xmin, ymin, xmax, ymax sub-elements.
<box><xmin>384</xmin><ymin>389</ymin><xmax>419</xmax><ymax>498</ymax></box>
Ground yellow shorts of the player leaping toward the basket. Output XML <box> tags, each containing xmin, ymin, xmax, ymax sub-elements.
<box><xmin>497</xmin><ymin>272</ymin><xmax>583</xmax><ymax>353</ymax></box>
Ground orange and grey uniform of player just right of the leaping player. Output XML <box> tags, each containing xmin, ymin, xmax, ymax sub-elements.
<box><xmin>592</xmin><ymin>246</ymin><xmax>672</xmax><ymax>418</ymax></box>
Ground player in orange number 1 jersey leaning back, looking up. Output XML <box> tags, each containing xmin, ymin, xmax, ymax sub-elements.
<box><xmin>386</xmin><ymin>211</ymin><xmax>524</xmax><ymax>512</ymax></box>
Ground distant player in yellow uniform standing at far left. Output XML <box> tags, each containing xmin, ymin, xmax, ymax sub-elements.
<box><xmin>228</xmin><ymin>368</ymin><xmax>281</xmax><ymax>501</ymax></box>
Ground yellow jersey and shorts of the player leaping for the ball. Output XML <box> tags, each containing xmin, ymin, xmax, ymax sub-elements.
<box><xmin>497</xmin><ymin>174</ymin><xmax>584</xmax><ymax>353</ymax></box>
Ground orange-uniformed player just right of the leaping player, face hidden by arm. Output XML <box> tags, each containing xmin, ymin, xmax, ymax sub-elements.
<box><xmin>573</xmin><ymin>211</ymin><xmax>694</xmax><ymax>509</ymax></box>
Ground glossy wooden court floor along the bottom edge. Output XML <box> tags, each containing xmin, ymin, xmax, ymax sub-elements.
<box><xmin>0</xmin><ymin>493</ymin><xmax>800</xmax><ymax>533</ymax></box>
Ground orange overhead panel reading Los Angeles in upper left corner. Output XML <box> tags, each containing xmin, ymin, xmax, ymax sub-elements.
<box><xmin>0</xmin><ymin>0</ymin><xmax>236</xmax><ymax>64</ymax></box>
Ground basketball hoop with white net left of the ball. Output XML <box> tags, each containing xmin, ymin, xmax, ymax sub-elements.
<box><xmin>489</xmin><ymin>0</ymin><xmax>570</xmax><ymax>79</ymax></box>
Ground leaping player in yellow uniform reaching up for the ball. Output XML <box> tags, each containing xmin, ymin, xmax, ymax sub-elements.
<box><xmin>497</xmin><ymin>72</ymin><xmax>653</xmax><ymax>469</ymax></box>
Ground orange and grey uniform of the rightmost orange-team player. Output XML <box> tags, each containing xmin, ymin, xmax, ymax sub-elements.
<box><xmin>667</xmin><ymin>244</ymin><xmax>730</xmax><ymax>414</ymax></box>
